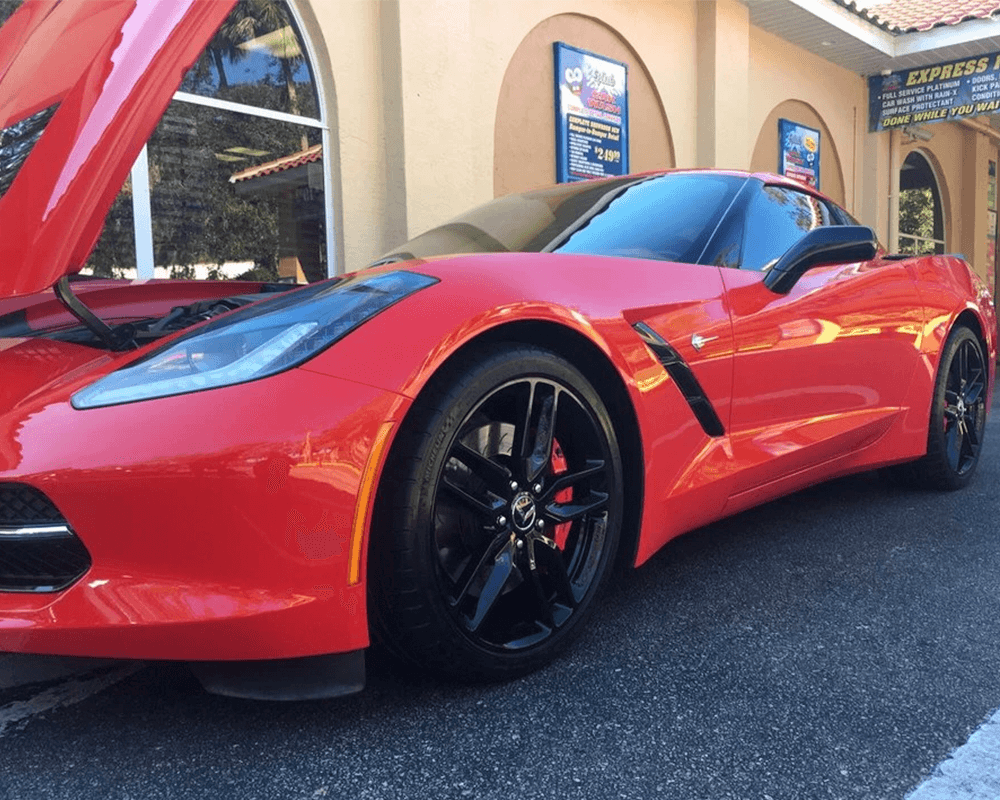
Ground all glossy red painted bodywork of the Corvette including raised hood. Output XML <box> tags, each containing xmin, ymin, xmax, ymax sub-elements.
<box><xmin>0</xmin><ymin>0</ymin><xmax>996</xmax><ymax>660</ymax></box>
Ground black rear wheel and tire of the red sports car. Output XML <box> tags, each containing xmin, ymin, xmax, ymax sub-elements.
<box><xmin>913</xmin><ymin>326</ymin><xmax>990</xmax><ymax>489</ymax></box>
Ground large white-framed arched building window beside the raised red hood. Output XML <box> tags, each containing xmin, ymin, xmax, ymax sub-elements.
<box><xmin>78</xmin><ymin>0</ymin><xmax>334</xmax><ymax>282</ymax></box>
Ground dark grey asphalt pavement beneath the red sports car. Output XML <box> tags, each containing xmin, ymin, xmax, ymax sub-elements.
<box><xmin>0</xmin><ymin>390</ymin><xmax>1000</xmax><ymax>800</ymax></box>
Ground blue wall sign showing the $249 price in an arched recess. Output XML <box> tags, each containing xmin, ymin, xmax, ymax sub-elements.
<box><xmin>553</xmin><ymin>42</ymin><xmax>628</xmax><ymax>183</ymax></box>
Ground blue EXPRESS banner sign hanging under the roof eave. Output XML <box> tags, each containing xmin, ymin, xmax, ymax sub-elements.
<box><xmin>868</xmin><ymin>53</ymin><xmax>1000</xmax><ymax>131</ymax></box>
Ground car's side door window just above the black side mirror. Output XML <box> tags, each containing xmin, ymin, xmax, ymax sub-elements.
<box><xmin>741</xmin><ymin>186</ymin><xmax>836</xmax><ymax>270</ymax></box>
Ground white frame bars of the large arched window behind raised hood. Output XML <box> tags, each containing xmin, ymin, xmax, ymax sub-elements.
<box><xmin>125</xmin><ymin>0</ymin><xmax>340</xmax><ymax>280</ymax></box>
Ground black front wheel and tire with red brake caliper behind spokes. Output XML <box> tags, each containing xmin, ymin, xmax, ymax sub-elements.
<box><xmin>372</xmin><ymin>347</ymin><xmax>622</xmax><ymax>679</ymax></box>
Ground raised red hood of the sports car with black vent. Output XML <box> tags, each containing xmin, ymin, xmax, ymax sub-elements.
<box><xmin>0</xmin><ymin>0</ymin><xmax>235</xmax><ymax>297</ymax></box>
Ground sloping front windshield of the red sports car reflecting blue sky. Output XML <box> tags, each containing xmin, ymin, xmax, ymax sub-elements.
<box><xmin>383</xmin><ymin>172</ymin><xmax>746</xmax><ymax>263</ymax></box>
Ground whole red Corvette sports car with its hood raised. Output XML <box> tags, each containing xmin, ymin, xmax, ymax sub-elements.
<box><xmin>0</xmin><ymin>0</ymin><xmax>996</xmax><ymax>697</ymax></box>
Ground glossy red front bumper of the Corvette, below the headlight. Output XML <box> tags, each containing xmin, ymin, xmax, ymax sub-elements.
<box><xmin>0</xmin><ymin>369</ymin><xmax>407</xmax><ymax>661</ymax></box>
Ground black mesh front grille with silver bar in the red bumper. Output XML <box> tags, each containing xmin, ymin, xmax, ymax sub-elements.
<box><xmin>0</xmin><ymin>483</ymin><xmax>90</xmax><ymax>592</ymax></box>
